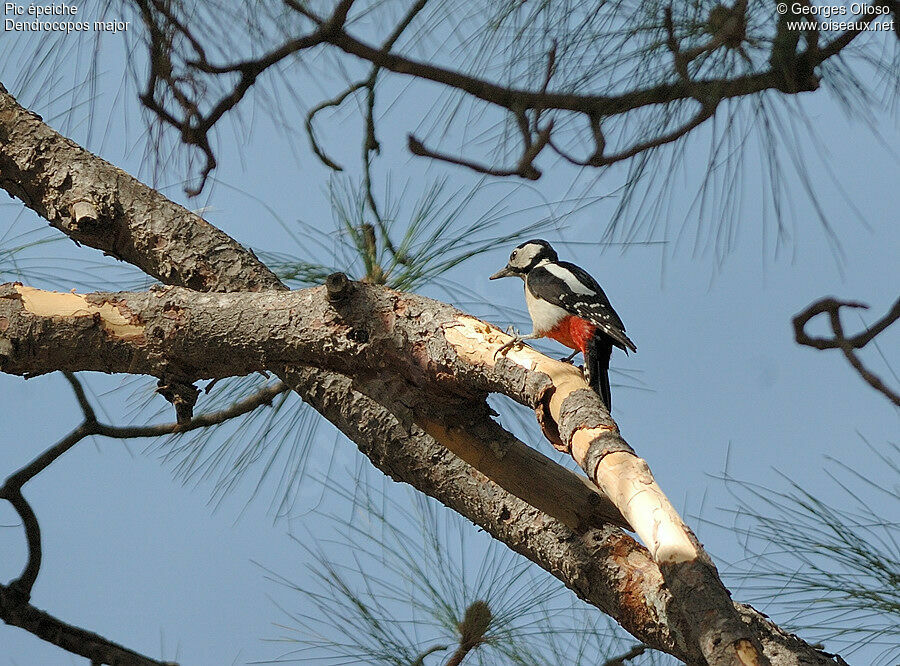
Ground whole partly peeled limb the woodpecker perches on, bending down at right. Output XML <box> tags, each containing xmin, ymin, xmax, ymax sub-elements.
<box><xmin>0</xmin><ymin>283</ymin><xmax>768</xmax><ymax>664</ymax></box>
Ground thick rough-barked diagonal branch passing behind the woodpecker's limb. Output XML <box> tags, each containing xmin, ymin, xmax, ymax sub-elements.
<box><xmin>0</xmin><ymin>83</ymin><xmax>695</xmax><ymax>655</ymax></box>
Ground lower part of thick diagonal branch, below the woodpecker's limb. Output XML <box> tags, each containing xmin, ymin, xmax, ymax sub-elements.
<box><xmin>285</xmin><ymin>368</ymin><xmax>692</xmax><ymax>666</ymax></box>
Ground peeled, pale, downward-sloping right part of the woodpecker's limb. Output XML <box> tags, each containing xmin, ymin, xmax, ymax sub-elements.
<box><xmin>445</xmin><ymin>316</ymin><xmax>771</xmax><ymax>666</ymax></box>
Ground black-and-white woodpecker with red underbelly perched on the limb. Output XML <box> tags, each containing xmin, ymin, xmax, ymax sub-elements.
<box><xmin>491</xmin><ymin>240</ymin><xmax>637</xmax><ymax>409</ymax></box>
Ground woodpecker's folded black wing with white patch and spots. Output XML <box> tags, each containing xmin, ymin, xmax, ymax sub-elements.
<box><xmin>525</xmin><ymin>261</ymin><xmax>637</xmax><ymax>351</ymax></box>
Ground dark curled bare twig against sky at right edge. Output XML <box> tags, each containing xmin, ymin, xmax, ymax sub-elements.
<box><xmin>793</xmin><ymin>298</ymin><xmax>900</xmax><ymax>407</ymax></box>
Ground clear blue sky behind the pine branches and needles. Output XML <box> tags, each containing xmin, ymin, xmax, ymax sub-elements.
<box><xmin>0</xmin><ymin>10</ymin><xmax>900</xmax><ymax>666</ymax></box>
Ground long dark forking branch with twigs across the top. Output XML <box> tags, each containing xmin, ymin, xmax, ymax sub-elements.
<box><xmin>138</xmin><ymin>0</ymin><xmax>864</xmax><ymax>189</ymax></box>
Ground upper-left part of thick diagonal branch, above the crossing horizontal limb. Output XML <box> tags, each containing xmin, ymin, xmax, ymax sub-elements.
<box><xmin>0</xmin><ymin>84</ymin><xmax>281</xmax><ymax>291</ymax></box>
